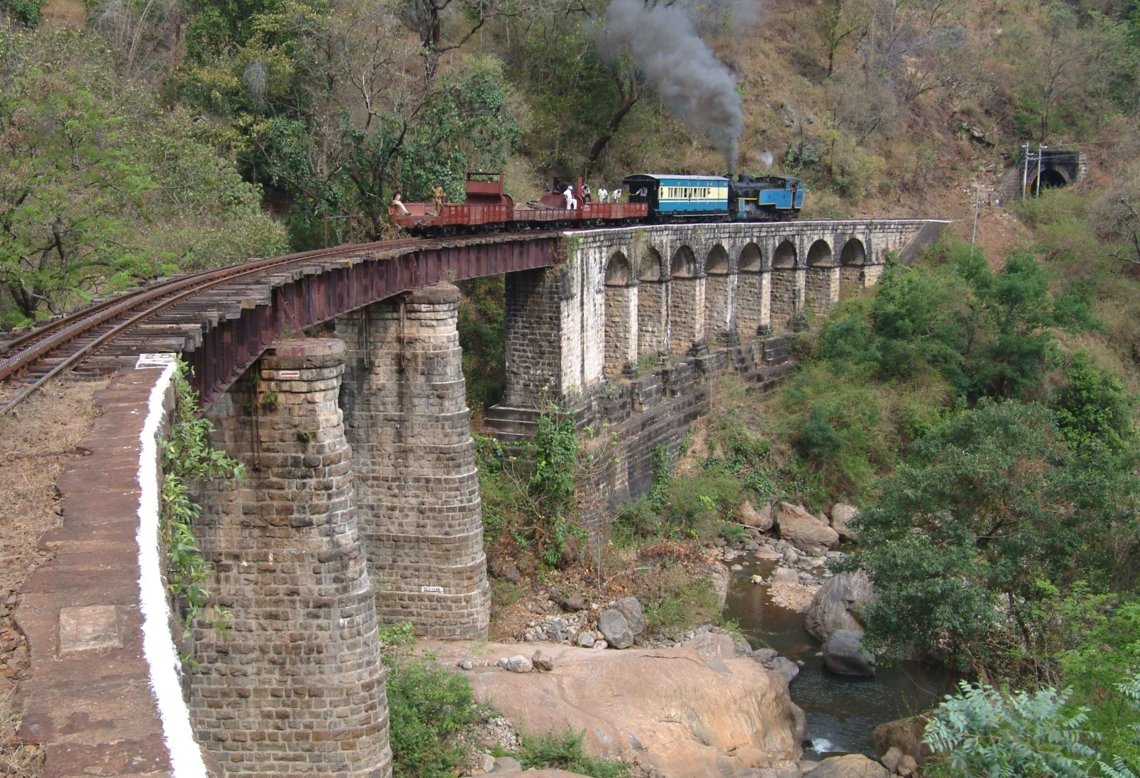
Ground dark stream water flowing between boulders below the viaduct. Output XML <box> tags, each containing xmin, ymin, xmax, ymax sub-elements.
<box><xmin>727</xmin><ymin>561</ymin><xmax>954</xmax><ymax>757</ymax></box>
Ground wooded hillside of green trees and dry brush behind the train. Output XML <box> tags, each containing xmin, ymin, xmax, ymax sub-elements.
<box><xmin>0</xmin><ymin>0</ymin><xmax>1140</xmax><ymax>325</ymax></box>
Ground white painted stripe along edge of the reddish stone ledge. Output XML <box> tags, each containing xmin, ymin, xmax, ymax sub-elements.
<box><xmin>136</xmin><ymin>355</ymin><xmax>207</xmax><ymax>778</ymax></box>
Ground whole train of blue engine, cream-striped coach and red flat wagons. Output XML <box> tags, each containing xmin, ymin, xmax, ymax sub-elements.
<box><xmin>389</xmin><ymin>167</ymin><xmax>804</xmax><ymax>235</ymax></box>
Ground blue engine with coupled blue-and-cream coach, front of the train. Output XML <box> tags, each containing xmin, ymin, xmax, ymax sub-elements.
<box><xmin>622</xmin><ymin>173</ymin><xmax>804</xmax><ymax>221</ymax></box>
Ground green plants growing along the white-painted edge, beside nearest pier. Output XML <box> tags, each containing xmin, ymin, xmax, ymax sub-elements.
<box><xmin>160</xmin><ymin>363</ymin><xmax>243</xmax><ymax>634</ymax></box>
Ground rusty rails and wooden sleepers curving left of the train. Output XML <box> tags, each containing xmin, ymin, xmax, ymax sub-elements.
<box><xmin>0</xmin><ymin>238</ymin><xmax>428</xmax><ymax>415</ymax></box>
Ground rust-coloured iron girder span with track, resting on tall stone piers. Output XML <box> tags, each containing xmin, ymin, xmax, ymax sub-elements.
<box><xmin>0</xmin><ymin>232</ymin><xmax>561</xmax><ymax>415</ymax></box>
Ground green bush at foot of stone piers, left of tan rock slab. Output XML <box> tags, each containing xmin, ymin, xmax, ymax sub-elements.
<box><xmin>381</xmin><ymin>623</ymin><xmax>486</xmax><ymax>778</ymax></box>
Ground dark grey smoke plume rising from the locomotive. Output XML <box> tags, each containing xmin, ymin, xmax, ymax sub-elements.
<box><xmin>597</xmin><ymin>0</ymin><xmax>744</xmax><ymax>171</ymax></box>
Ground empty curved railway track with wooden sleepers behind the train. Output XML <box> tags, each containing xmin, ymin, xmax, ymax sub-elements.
<box><xmin>0</xmin><ymin>238</ymin><xmax>438</xmax><ymax>415</ymax></box>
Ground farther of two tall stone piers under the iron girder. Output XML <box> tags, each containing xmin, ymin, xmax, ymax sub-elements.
<box><xmin>336</xmin><ymin>284</ymin><xmax>490</xmax><ymax>639</ymax></box>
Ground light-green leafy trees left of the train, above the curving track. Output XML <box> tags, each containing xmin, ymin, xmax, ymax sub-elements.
<box><xmin>0</xmin><ymin>29</ymin><xmax>284</xmax><ymax>324</ymax></box>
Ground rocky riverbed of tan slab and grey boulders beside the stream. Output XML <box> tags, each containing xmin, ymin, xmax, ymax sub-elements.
<box><xmin>440</xmin><ymin>505</ymin><xmax>930</xmax><ymax>778</ymax></box>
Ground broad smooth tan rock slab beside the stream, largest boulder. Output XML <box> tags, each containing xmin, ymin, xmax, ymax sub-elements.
<box><xmin>435</xmin><ymin>641</ymin><xmax>801</xmax><ymax>776</ymax></box>
